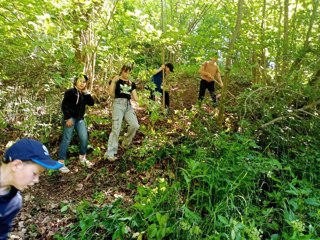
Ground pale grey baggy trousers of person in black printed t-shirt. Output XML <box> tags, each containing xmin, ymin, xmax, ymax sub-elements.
<box><xmin>107</xmin><ymin>98</ymin><xmax>140</xmax><ymax>157</ymax></box>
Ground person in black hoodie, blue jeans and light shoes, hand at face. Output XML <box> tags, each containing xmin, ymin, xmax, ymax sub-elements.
<box><xmin>58</xmin><ymin>74</ymin><xmax>94</xmax><ymax>173</ymax></box>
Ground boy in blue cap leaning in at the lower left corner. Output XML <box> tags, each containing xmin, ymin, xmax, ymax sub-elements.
<box><xmin>0</xmin><ymin>139</ymin><xmax>63</xmax><ymax>240</ymax></box>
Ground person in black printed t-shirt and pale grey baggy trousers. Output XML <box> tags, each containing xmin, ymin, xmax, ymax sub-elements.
<box><xmin>104</xmin><ymin>65</ymin><xmax>140</xmax><ymax>161</ymax></box>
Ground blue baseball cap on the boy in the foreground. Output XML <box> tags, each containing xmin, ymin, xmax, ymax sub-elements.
<box><xmin>4</xmin><ymin>138</ymin><xmax>63</xmax><ymax>170</ymax></box>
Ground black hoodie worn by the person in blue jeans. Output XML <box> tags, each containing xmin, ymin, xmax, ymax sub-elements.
<box><xmin>61</xmin><ymin>87</ymin><xmax>94</xmax><ymax>120</ymax></box>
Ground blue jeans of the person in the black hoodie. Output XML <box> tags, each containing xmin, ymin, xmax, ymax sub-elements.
<box><xmin>58</xmin><ymin>118</ymin><xmax>88</xmax><ymax>160</ymax></box>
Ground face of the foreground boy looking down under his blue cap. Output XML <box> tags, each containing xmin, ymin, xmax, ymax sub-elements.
<box><xmin>12</xmin><ymin>160</ymin><xmax>45</xmax><ymax>191</ymax></box>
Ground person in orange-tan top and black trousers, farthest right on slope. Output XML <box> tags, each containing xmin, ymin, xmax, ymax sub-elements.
<box><xmin>198</xmin><ymin>57</ymin><xmax>223</xmax><ymax>106</ymax></box>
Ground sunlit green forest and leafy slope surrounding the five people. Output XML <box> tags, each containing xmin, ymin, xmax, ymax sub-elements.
<box><xmin>0</xmin><ymin>0</ymin><xmax>320</xmax><ymax>240</ymax></box>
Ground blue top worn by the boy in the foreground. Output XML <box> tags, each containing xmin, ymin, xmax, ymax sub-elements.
<box><xmin>0</xmin><ymin>187</ymin><xmax>22</xmax><ymax>240</ymax></box>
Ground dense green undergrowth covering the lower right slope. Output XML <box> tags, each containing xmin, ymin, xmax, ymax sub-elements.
<box><xmin>55</xmin><ymin>103</ymin><xmax>320</xmax><ymax>240</ymax></box>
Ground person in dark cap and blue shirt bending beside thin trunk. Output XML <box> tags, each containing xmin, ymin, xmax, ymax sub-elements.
<box><xmin>150</xmin><ymin>63</ymin><xmax>173</xmax><ymax>108</ymax></box>
